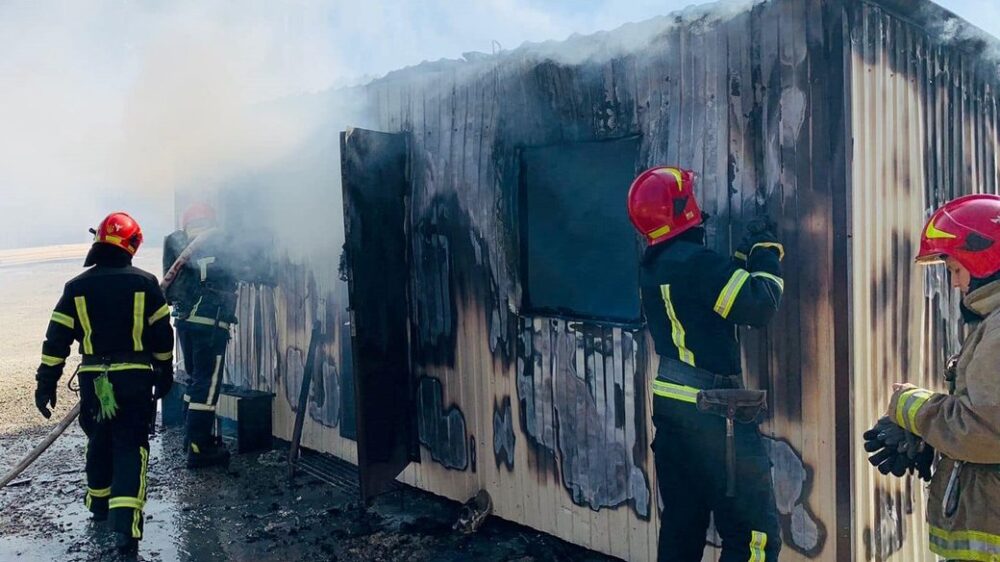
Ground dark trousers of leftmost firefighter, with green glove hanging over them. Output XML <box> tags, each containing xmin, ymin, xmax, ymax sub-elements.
<box><xmin>79</xmin><ymin>369</ymin><xmax>153</xmax><ymax>539</ymax></box>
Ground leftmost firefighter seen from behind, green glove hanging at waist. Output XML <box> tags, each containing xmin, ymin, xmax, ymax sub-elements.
<box><xmin>35</xmin><ymin>212</ymin><xmax>174</xmax><ymax>555</ymax></box>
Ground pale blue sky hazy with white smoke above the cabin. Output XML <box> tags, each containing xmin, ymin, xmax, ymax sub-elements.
<box><xmin>0</xmin><ymin>0</ymin><xmax>1000</xmax><ymax>249</ymax></box>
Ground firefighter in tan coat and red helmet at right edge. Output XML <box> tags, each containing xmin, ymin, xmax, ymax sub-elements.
<box><xmin>866</xmin><ymin>195</ymin><xmax>1000</xmax><ymax>560</ymax></box>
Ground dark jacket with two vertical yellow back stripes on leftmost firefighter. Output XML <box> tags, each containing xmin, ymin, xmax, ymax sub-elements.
<box><xmin>37</xmin><ymin>244</ymin><xmax>174</xmax><ymax>381</ymax></box>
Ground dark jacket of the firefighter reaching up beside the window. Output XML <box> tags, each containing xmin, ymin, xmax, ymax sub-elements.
<box><xmin>639</xmin><ymin>232</ymin><xmax>784</xmax><ymax>376</ymax></box>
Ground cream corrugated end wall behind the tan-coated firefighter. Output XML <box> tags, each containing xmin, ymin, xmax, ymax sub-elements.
<box><xmin>848</xmin><ymin>2</ymin><xmax>1000</xmax><ymax>561</ymax></box>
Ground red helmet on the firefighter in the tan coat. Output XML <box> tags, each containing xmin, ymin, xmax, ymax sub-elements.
<box><xmin>917</xmin><ymin>194</ymin><xmax>1000</xmax><ymax>279</ymax></box>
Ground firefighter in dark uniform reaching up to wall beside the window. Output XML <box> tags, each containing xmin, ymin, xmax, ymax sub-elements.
<box><xmin>628</xmin><ymin>167</ymin><xmax>784</xmax><ymax>562</ymax></box>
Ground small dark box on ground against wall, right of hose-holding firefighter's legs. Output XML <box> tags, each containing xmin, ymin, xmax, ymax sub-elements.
<box><xmin>215</xmin><ymin>385</ymin><xmax>274</xmax><ymax>453</ymax></box>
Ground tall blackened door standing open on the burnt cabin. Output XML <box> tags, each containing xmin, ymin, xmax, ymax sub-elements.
<box><xmin>340</xmin><ymin>129</ymin><xmax>419</xmax><ymax>502</ymax></box>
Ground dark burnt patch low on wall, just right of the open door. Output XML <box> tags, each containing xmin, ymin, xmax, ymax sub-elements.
<box><xmin>417</xmin><ymin>376</ymin><xmax>474</xmax><ymax>470</ymax></box>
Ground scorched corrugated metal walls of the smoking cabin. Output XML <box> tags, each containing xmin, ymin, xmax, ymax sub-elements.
<box><xmin>213</xmin><ymin>0</ymin><xmax>998</xmax><ymax>561</ymax></box>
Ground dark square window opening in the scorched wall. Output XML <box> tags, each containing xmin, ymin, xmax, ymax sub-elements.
<box><xmin>519</xmin><ymin>137</ymin><xmax>641</xmax><ymax>323</ymax></box>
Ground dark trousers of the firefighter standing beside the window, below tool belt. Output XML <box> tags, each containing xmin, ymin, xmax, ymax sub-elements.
<box><xmin>653</xmin><ymin>396</ymin><xmax>781</xmax><ymax>562</ymax></box>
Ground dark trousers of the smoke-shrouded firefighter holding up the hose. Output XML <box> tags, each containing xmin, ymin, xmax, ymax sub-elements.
<box><xmin>177</xmin><ymin>320</ymin><xmax>229</xmax><ymax>446</ymax></box>
